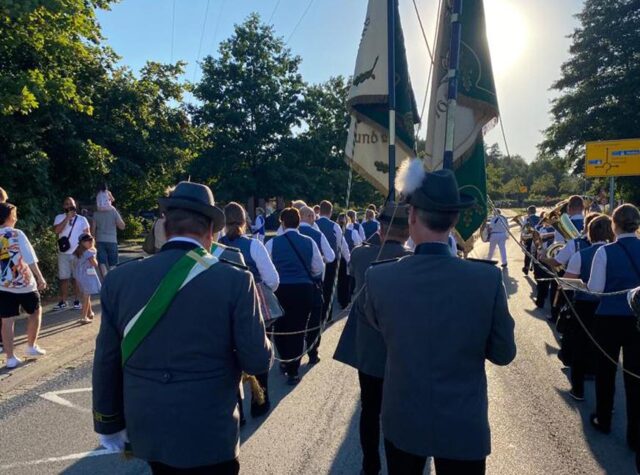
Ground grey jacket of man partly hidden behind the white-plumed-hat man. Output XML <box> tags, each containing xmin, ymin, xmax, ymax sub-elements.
<box><xmin>333</xmin><ymin>241</ymin><xmax>412</xmax><ymax>378</ymax></box>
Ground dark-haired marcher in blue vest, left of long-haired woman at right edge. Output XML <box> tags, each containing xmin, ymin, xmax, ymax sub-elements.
<box><xmin>563</xmin><ymin>215</ymin><xmax>615</xmax><ymax>401</ymax></box>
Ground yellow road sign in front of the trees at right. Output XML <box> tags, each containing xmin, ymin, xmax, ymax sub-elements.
<box><xmin>585</xmin><ymin>139</ymin><xmax>640</xmax><ymax>177</ymax></box>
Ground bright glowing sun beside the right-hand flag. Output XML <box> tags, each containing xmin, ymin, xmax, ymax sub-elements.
<box><xmin>484</xmin><ymin>0</ymin><xmax>528</xmax><ymax>76</ymax></box>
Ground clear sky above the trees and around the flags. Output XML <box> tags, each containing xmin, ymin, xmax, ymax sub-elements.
<box><xmin>98</xmin><ymin>0</ymin><xmax>583</xmax><ymax>161</ymax></box>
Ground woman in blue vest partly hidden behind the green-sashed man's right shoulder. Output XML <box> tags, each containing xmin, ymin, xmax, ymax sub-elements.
<box><xmin>219</xmin><ymin>201</ymin><xmax>280</xmax><ymax>417</ymax></box>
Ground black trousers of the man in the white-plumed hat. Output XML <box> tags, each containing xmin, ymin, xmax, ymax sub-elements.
<box><xmin>384</xmin><ymin>439</ymin><xmax>486</xmax><ymax>475</ymax></box>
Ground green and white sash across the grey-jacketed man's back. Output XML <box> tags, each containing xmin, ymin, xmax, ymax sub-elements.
<box><xmin>121</xmin><ymin>248</ymin><xmax>218</xmax><ymax>366</ymax></box>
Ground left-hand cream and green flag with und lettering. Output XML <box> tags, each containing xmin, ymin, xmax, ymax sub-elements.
<box><xmin>345</xmin><ymin>0</ymin><xmax>420</xmax><ymax>194</ymax></box>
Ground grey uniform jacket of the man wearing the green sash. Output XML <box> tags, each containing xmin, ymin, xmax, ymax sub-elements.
<box><xmin>93</xmin><ymin>242</ymin><xmax>272</xmax><ymax>468</ymax></box>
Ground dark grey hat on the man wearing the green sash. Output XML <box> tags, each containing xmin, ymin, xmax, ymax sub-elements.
<box><xmin>158</xmin><ymin>181</ymin><xmax>224</xmax><ymax>233</ymax></box>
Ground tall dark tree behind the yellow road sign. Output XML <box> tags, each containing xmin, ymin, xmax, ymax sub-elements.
<box><xmin>540</xmin><ymin>0</ymin><xmax>640</xmax><ymax>201</ymax></box>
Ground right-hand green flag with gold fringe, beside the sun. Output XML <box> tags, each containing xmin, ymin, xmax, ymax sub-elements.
<box><xmin>425</xmin><ymin>0</ymin><xmax>498</xmax><ymax>240</ymax></box>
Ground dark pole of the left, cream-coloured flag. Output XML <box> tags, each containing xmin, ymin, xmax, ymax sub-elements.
<box><xmin>387</xmin><ymin>0</ymin><xmax>398</xmax><ymax>203</ymax></box>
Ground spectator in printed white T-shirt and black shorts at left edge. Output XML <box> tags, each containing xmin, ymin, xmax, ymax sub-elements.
<box><xmin>0</xmin><ymin>203</ymin><xmax>47</xmax><ymax>369</ymax></box>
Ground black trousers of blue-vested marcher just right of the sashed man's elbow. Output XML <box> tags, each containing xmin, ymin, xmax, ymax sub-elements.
<box><xmin>273</xmin><ymin>284</ymin><xmax>313</xmax><ymax>376</ymax></box>
